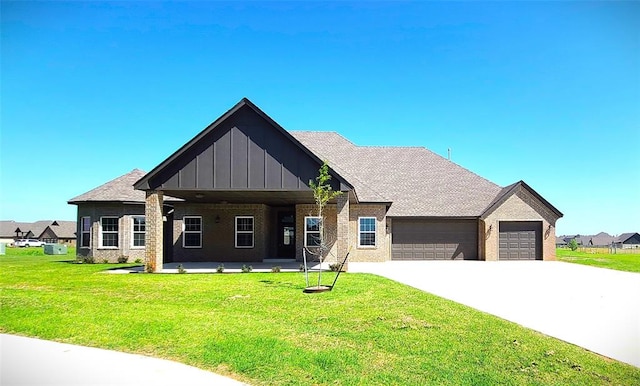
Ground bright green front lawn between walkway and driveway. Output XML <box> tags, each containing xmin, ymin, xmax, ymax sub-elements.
<box><xmin>0</xmin><ymin>248</ymin><xmax>640</xmax><ymax>385</ymax></box>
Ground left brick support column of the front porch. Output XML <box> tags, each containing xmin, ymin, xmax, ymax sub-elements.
<box><xmin>144</xmin><ymin>190</ymin><xmax>163</xmax><ymax>272</ymax></box>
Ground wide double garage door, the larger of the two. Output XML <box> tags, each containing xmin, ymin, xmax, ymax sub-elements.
<box><xmin>391</xmin><ymin>219</ymin><xmax>478</xmax><ymax>260</ymax></box>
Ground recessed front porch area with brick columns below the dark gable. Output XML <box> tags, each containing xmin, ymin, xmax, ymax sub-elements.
<box><xmin>145</xmin><ymin>191</ymin><xmax>350</xmax><ymax>272</ymax></box>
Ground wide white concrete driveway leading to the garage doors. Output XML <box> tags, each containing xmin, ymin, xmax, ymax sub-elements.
<box><xmin>349</xmin><ymin>261</ymin><xmax>640</xmax><ymax>367</ymax></box>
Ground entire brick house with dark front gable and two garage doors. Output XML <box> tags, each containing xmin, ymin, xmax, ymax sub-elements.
<box><xmin>69</xmin><ymin>98</ymin><xmax>562</xmax><ymax>270</ymax></box>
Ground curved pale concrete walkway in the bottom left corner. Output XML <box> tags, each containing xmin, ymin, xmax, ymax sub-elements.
<box><xmin>0</xmin><ymin>334</ymin><xmax>244</xmax><ymax>386</ymax></box>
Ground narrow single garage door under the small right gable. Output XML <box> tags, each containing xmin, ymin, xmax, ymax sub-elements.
<box><xmin>499</xmin><ymin>221</ymin><xmax>542</xmax><ymax>260</ymax></box>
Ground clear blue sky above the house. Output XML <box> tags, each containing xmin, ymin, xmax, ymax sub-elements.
<box><xmin>0</xmin><ymin>1</ymin><xmax>640</xmax><ymax>234</ymax></box>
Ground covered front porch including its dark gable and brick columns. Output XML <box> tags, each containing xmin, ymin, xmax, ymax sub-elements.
<box><xmin>134</xmin><ymin>98</ymin><xmax>358</xmax><ymax>272</ymax></box>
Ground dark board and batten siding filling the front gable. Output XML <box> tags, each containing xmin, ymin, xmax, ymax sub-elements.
<box><xmin>152</xmin><ymin>107</ymin><xmax>338</xmax><ymax>190</ymax></box>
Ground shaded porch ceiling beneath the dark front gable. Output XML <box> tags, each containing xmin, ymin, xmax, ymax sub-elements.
<box><xmin>163</xmin><ymin>190</ymin><xmax>354</xmax><ymax>205</ymax></box>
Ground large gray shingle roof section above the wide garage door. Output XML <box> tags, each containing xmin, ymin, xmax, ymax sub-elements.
<box><xmin>291</xmin><ymin>131</ymin><xmax>502</xmax><ymax>217</ymax></box>
